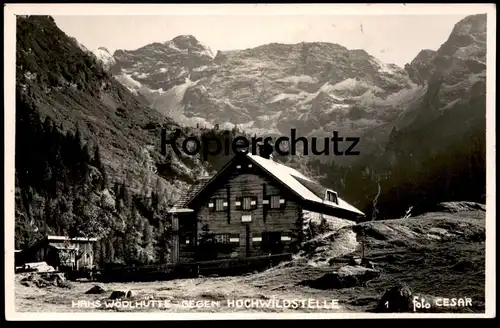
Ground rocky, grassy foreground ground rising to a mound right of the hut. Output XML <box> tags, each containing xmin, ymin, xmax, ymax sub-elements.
<box><xmin>15</xmin><ymin>205</ymin><xmax>485</xmax><ymax>313</ymax></box>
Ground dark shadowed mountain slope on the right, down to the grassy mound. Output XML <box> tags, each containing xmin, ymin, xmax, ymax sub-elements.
<box><xmin>346</xmin><ymin>15</ymin><xmax>486</xmax><ymax>216</ymax></box>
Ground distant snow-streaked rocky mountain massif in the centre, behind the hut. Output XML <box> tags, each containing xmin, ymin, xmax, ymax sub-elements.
<box><xmin>94</xmin><ymin>36</ymin><xmax>421</xmax><ymax>135</ymax></box>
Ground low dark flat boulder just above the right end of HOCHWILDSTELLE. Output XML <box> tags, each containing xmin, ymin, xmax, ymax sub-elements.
<box><xmin>301</xmin><ymin>265</ymin><xmax>379</xmax><ymax>289</ymax></box>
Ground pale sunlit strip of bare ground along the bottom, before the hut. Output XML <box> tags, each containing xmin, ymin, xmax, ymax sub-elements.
<box><xmin>16</xmin><ymin>277</ymin><xmax>351</xmax><ymax>312</ymax></box>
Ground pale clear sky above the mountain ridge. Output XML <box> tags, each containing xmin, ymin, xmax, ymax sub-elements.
<box><xmin>53</xmin><ymin>14</ymin><xmax>476</xmax><ymax>67</ymax></box>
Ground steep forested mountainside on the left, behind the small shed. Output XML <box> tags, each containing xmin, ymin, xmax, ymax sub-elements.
<box><xmin>15</xmin><ymin>15</ymin><xmax>221</xmax><ymax>265</ymax></box>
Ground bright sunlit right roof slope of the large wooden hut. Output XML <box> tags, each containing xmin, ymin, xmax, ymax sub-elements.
<box><xmin>247</xmin><ymin>153</ymin><xmax>364</xmax><ymax>215</ymax></box>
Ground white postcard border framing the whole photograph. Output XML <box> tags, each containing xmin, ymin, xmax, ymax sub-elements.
<box><xmin>4</xmin><ymin>4</ymin><xmax>496</xmax><ymax>321</ymax></box>
